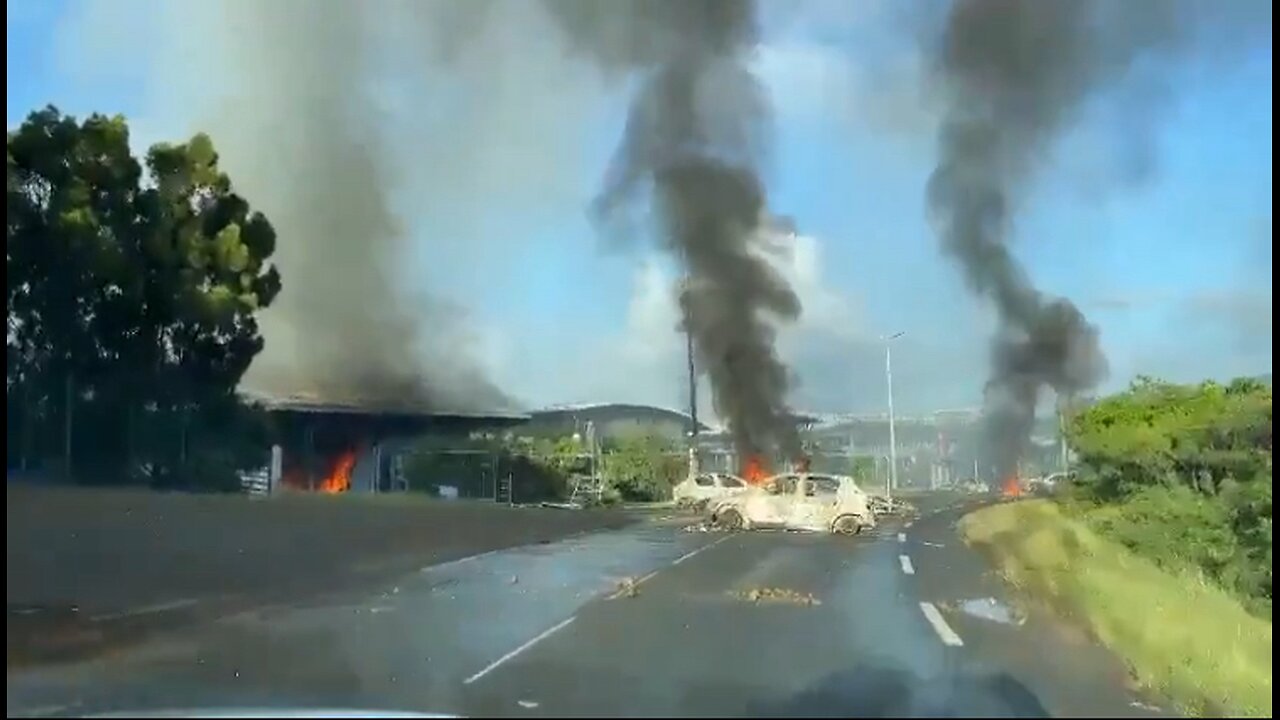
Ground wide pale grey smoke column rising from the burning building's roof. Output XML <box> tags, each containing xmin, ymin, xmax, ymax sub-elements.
<box><xmin>188</xmin><ymin>0</ymin><xmax>509</xmax><ymax>410</ymax></box>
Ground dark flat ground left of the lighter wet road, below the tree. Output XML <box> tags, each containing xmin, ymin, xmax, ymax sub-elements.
<box><xmin>5</xmin><ymin>483</ymin><xmax>635</xmax><ymax>667</ymax></box>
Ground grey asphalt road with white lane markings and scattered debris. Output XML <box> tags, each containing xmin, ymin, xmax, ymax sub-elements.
<box><xmin>8</xmin><ymin>501</ymin><xmax>1158</xmax><ymax>717</ymax></box>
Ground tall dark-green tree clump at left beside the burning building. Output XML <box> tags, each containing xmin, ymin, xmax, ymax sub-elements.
<box><xmin>5</xmin><ymin>106</ymin><xmax>280</xmax><ymax>480</ymax></box>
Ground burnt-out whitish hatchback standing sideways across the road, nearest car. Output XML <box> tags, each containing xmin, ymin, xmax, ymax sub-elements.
<box><xmin>708</xmin><ymin>473</ymin><xmax>876</xmax><ymax>536</ymax></box>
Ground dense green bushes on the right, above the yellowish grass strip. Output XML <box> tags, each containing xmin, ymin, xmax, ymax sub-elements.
<box><xmin>1068</xmin><ymin>378</ymin><xmax>1272</xmax><ymax>612</ymax></box>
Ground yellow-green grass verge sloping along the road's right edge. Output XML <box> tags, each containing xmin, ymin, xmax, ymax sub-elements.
<box><xmin>960</xmin><ymin>500</ymin><xmax>1272</xmax><ymax>717</ymax></box>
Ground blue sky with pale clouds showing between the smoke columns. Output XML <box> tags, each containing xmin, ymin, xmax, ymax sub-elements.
<box><xmin>6</xmin><ymin>0</ymin><xmax>1271</xmax><ymax>410</ymax></box>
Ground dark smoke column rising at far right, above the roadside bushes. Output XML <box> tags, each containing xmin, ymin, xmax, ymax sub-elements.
<box><xmin>928</xmin><ymin>0</ymin><xmax>1178</xmax><ymax>477</ymax></box>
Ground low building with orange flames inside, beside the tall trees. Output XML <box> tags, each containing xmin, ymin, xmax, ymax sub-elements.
<box><xmin>247</xmin><ymin>396</ymin><xmax>529</xmax><ymax>493</ymax></box>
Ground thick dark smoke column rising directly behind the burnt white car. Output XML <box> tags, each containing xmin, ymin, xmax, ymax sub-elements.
<box><xmin>548</xmin><ymin>0</ymin><xmax>800</xmax><ymax>457</ymax></box>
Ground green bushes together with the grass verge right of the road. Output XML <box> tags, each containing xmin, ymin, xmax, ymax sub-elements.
<box><xmin>963</xmin><ymin>378</ymin><xmax>1272</xmax><ymax>716</ymax></box>
